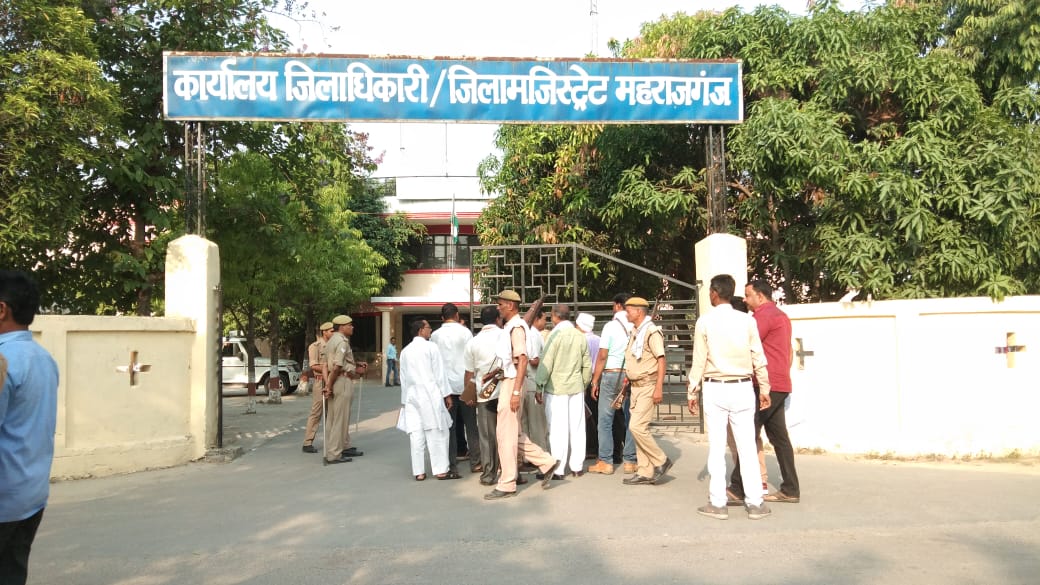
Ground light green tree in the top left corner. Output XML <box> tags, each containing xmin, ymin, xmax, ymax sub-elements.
<box><xmin>0</xmin><ymin>0</ymin><xmax>119</xmax><ymax>291</ymax></box>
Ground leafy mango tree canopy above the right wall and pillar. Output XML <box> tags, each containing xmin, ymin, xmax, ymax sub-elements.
<box><xmin>479</xmin><ymin>0</ymin><xmax>1040</xmax><ymax>302</ymax></box>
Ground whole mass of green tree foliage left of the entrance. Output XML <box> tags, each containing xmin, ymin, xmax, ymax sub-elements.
<box><xmin>0</xmin><ymin>0</ymin><xmax>419</xmax><ymax>353</ymax></box>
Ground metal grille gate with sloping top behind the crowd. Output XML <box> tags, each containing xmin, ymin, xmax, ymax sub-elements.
<box><xmin>469</xmin><ymin>244</ymin><xmax>704</xmax><ymax>432</ymax></box>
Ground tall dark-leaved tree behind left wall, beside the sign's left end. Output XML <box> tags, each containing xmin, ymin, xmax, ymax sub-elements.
<box><xmin>59</xmin><ymin>0</ymin><xmax>293</xmax><ymax>314</ymax></box>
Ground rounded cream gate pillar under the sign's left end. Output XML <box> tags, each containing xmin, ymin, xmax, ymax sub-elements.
<box><xmin>166</xmin><ymin>235</ymin><xmax>220</xmax><ymax>451</ymax></box>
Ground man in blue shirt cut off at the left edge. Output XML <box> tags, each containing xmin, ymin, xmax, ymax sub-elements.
<box><xmin>0</xmin><ymin>271</ymin><xmax>58</xmax><ymax>585</ymax></box>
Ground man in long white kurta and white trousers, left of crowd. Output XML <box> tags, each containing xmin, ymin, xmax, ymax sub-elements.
<box><xmin>400</xmin><ymin>321</ymin><xmax>451</xmax><ymax>480</ymax></box>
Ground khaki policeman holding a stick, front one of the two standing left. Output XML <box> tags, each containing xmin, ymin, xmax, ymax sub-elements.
<box><xmin>324</xmin><ymin>314</ymin><xmax>368</xmax><ymax>465</ymax></box>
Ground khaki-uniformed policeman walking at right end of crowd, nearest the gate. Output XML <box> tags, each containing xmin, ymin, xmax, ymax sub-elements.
<box><xmin>622</xmin><ymin>297</ymin><xmax>672</xmax><ymax>485</ymax></box>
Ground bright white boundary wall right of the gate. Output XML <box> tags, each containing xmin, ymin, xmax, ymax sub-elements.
<box><xmin>782</xmin><ymin>296</ymin><xmax>1040</xmax><ymax>457</ymax></box>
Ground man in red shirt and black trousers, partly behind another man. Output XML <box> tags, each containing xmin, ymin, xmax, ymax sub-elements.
<box><xmin>729</xmin><ymin>279</ymin><xmax>801</xmax><ymax>504</ymax></box>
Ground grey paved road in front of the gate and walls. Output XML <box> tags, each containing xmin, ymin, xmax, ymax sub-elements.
<box><xmin>29</xmin><ymin>385</ymin><xmax>1040</xmax><ymax>585</ymax></box>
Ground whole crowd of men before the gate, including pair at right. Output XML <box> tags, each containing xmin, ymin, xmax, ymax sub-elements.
<box><xmin>370</xmin><ymin>275</ymin><xmax>800</xmax><ymax>519</ymax></box>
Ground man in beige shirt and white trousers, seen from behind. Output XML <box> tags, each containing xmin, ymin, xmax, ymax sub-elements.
<box><xmin>686</xmin><ymin>274</ymin><xmax>771</xmax><ymax>519</ymax></box>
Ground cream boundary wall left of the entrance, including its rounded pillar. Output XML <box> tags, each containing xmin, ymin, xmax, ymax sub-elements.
<box><xmin>30</xmin><ymin>235</ymin><xmax>220</xmax><ymax>479</ymax></box>
